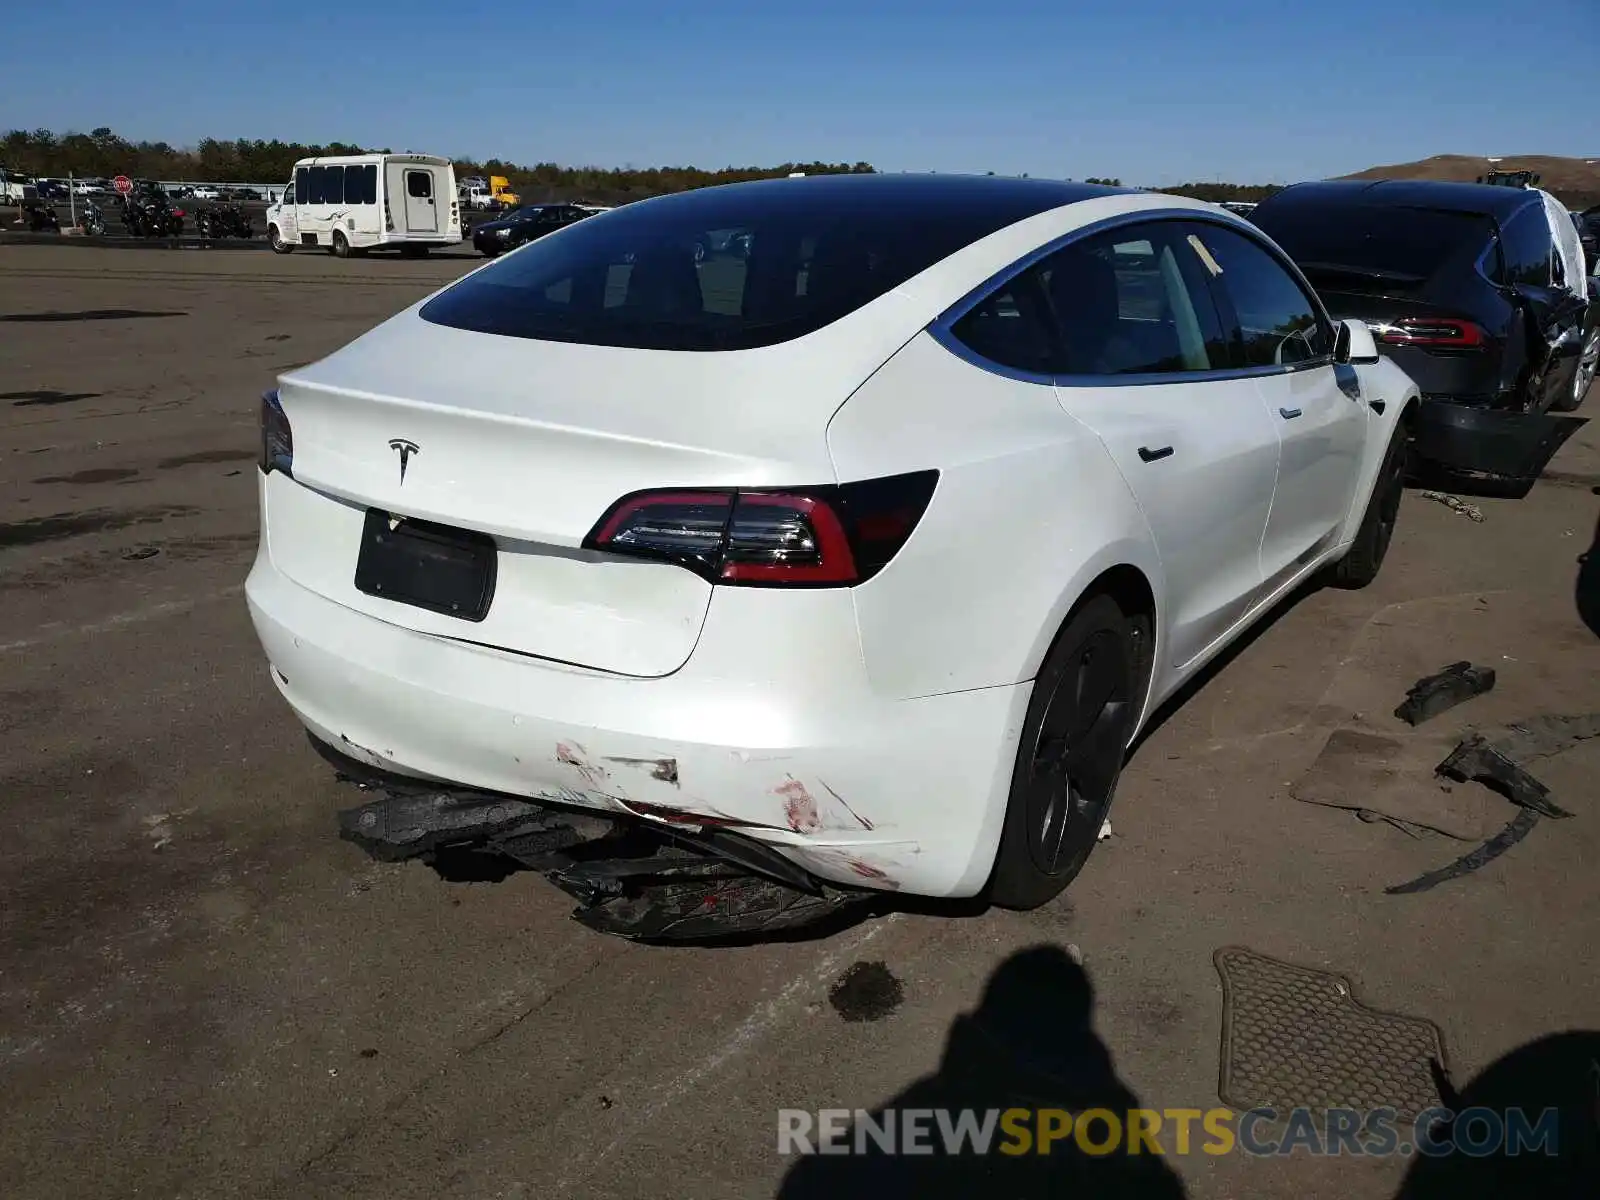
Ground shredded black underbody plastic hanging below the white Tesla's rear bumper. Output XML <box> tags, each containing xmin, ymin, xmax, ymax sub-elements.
<box><xmin>329</xmin><ymin>773</ymin><xmax>877</xmax><ymax>941</ymax></box>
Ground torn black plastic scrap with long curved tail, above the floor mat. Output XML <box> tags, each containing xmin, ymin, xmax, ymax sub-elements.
<box><xmin>1384</xmin><ymin>712</ymin><xmax>1600</xmax><ymax>896</ymax></box>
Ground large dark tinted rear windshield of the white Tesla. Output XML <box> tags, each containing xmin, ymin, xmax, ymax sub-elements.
<box><xmin>422</xmin><ymin>176</ymin><xmax>1064</xmax><ymax>350</ymax></box>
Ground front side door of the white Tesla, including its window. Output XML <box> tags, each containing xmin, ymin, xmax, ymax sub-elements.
<box><xmin>1192</xmin><ymin>222</ymin><xmax>1368</xmax><ymax>592</ymax></box>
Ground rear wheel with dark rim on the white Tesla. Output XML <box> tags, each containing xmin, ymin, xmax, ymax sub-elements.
<box><xmin>989</xmin><ymin>594</ymin><xmax>1150</xmax><ymax>909</ymax></box>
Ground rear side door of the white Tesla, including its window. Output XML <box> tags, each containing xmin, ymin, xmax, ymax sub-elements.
<box><xmin>1037</xmin><ymin>219</ymin><xmax>1278</xmax><ymax>670</ymax></box>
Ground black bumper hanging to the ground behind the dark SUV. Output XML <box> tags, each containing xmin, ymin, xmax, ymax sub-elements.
<box><xmin>1413</xmin><ymin>397</ymin><xmax>1587</xmax><ymax>480</ymax></box>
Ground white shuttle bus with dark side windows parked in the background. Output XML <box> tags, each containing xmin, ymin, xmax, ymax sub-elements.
<box><xmin>267</xmin><ymin>154</ymin><xmax>461</xmax><ymax>258</ymax></box>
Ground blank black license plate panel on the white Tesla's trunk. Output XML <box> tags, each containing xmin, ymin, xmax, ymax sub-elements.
<box><xmin>355</xmin><ymin>509</ymin><xmax>499</xmax><ymax>621</ymax></box>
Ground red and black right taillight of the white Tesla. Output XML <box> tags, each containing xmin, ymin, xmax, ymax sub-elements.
<box><xmin>584</xmin><ymin>470</ymin><xmax>939</xmax><ymax>587</ymax></box>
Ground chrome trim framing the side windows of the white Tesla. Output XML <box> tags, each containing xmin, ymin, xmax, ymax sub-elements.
<box><xmin>926</xmin><ymin>208</ymin><xmax>1338</xmax><ymax>387</ymax></box>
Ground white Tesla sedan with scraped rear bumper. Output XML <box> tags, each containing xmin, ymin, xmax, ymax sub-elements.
<box><xmin>248</xmin><ymin>176</ymin><xmax>1416</xmax><ymax>906</ymax></box>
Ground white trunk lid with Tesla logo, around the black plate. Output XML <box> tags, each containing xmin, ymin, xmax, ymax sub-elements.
<box><xmin>266</xmin><ymin>298</ymin><xmax>894</xmax><ymax>677</ymax></box>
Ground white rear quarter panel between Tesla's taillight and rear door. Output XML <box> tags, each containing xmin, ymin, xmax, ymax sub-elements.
<box><xmin>827</xmin><ymin>333</ymin><xmax>1163</xmax><ymax>698</ymax></box>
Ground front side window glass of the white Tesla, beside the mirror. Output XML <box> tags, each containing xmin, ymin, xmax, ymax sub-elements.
<box><xmin>1194</xmin><ymin>224</ymin><xmax>1333</xmax><ymax>366</ymax></box>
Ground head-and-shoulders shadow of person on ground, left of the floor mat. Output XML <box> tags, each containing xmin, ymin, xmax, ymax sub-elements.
<box><xmin>778</xmin><ymin>946</ymin><xmax>1184</xmax><ymax>1200</ymax></box>
